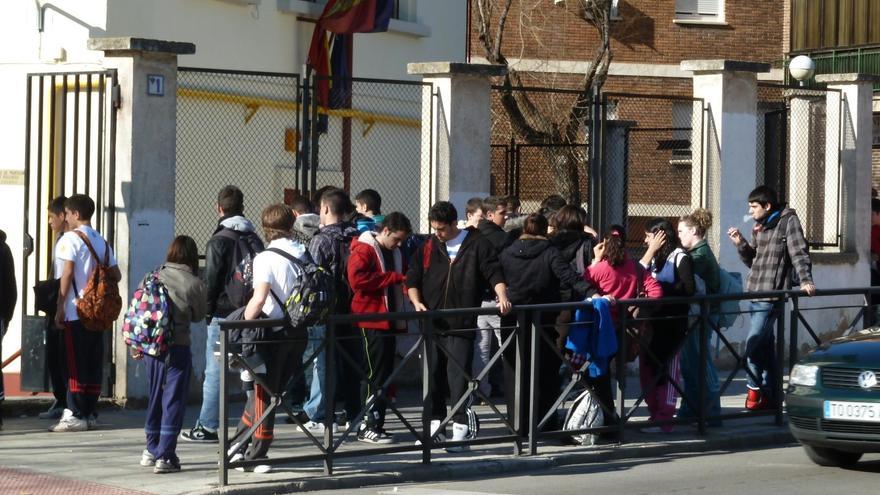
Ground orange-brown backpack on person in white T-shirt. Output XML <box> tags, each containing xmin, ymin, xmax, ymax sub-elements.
<box><xmin>74</xmin><ymin>230</ymin><xmax>122</xmax><ymax>332</ymax></box>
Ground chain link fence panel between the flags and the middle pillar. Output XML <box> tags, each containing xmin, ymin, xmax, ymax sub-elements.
<box><xmin>311</xmin><ymin>78</ymin><xmax>433</xmax><ymax>226</ymax></box>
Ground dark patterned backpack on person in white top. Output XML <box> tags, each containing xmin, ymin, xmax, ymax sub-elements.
<box><xmin>268</xmin><ymin>248</ymin><xmax>336</xmax><ymax>328</ymax></box>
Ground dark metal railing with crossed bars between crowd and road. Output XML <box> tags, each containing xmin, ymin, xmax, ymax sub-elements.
<box><xmin>218</xmin><ymin>287</ymin><xmax>880</xmax><ymax>486</ymax></box>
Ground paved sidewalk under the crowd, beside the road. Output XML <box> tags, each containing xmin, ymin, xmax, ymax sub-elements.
<box><xmin>0</xmin><ymin>384</ymin><xmax>793</xmax><ymax>494</ymax></box>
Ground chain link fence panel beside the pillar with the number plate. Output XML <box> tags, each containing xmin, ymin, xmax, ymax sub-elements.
<box><xmin>174</xmin><ymin>68</ymin><xmax>300</xmax><ymax>249</ymax></box>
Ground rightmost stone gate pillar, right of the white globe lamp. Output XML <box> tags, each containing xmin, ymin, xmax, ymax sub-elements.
<box><xmin>816</xmin><ymin>74</ymin><xmax>880</xmax><ymax>260</ymax></box>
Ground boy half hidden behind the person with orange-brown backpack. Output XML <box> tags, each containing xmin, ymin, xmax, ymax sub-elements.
<box><xmin>39</xmin><ymin>196</ymin><xmax>68</xmax><ymax>419</ymax></box>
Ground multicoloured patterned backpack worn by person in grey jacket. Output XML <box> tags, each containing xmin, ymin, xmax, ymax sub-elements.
<box><xmin>122</xmin><ymin>270</ymin><xmax>174</xmax><ymax>357</ymax></box>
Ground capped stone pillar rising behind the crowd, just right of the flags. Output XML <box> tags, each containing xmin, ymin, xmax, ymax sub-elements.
<box><xmin>407</xmin><ymin>62</ymin><xmax>507</xmax><ymax>232</ymax></box>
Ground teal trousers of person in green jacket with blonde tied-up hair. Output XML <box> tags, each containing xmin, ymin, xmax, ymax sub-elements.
<box><xmin>678</xmin><ymin>314</ymin><xmax>721</xmax><ymax>418</ymax></box>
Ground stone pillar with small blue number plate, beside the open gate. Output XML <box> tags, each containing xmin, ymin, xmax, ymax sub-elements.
<box><xmin>88</xmin><ymin>38</ymin><xmax>195</xmax><ymax>401</ymax></box>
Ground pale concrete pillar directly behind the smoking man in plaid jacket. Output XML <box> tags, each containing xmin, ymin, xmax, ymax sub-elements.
<box><xmin>681</xmin><ymin>60</ymin><xmax>770</xmax><ymax>272</ymax></box>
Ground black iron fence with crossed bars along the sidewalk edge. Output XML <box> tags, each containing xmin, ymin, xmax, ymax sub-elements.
<box><xmin>219</xmin><ymin>287</ymin><xmax>880</xmax><ymax>485</ymax></box>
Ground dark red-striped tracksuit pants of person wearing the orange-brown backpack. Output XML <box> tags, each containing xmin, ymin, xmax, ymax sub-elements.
<box><xmin>63</xmin><ymin>320</ymin><xmax>104</xmax><ymax>419</ymax></box>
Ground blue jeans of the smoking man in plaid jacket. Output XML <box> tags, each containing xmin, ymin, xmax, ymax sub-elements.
<box><xmin>745</xmin><ymin>301</ymin><xmax>781</xmax><ymax>392</ymax></box>
